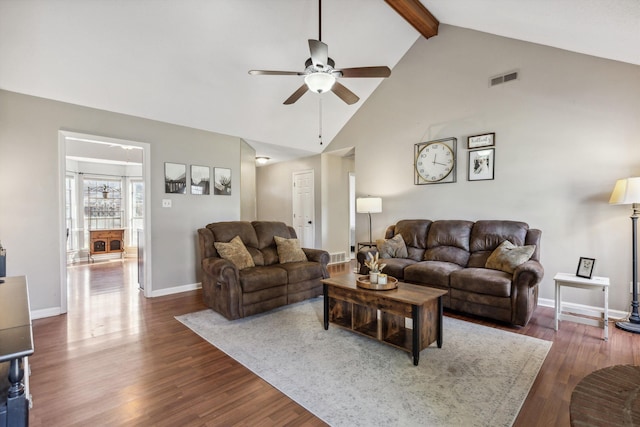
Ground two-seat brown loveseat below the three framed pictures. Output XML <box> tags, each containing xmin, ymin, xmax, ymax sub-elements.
<box><xmin>198</xmin><ymin>221</ymin><xmax>329</xmax><ymax>319</ymax></box>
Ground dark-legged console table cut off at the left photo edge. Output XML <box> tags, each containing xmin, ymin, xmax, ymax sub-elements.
<box><xmin>0</xmin><ymin>276</ymin><xmax>33</xmax><ymax>427</ymax></box>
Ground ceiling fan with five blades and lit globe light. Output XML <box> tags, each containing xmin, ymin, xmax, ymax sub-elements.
<box><xmin>249</xmin><ymin>0</ymin><xmax>391</xmax><ymax>105</ymax></box>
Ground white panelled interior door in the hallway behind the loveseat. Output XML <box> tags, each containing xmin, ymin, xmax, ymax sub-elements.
<box><xmin>293</xmin><ymin>170</ymin><xmax>316</xmax><ymax>248</ymax></box>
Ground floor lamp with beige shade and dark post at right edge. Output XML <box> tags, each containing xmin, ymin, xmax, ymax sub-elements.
<box><xmin>609</xmin><ymin>177</ymin><xmax>640</xmax><ymax>334</ymax></box>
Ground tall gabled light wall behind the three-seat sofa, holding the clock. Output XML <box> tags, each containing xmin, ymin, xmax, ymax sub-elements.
<box><xmin>327</xmin><ymin>25</ymin><xmax>640</xmax><ymax>310</ymax></box>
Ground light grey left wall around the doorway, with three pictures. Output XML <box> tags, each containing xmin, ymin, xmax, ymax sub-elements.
<box><xmin>0</xmin><ymin>91</ymin><xmax>241</xmax><ymax>313</ymax></box>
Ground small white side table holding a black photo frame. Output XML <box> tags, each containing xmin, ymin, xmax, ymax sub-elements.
<box><xmin>553</xmin><ymin>273</ymin><xmax>609</xmax><ymax>341</ymax></box>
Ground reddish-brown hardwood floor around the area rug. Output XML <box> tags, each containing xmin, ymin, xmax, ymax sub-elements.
<box><xmin>30</xmin><ymin>260</ymin><xmax>640</xmax><ymax>426</ymax></box>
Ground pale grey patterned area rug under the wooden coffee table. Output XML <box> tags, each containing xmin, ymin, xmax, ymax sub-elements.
<box><xmin>177</xmin><ymin>298</ymin><xmax>551</xmax><ymax>427</ymax></box>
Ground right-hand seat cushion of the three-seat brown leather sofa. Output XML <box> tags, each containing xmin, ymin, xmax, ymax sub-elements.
<box><xmin>450</xmin><ymin>268</ymin><xmax>513</xmax><ymax>298</ymax></box>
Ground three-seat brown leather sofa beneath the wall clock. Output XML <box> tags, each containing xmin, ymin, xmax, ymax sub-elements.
<box><xmin>357</xmin><ymin>220</ymin><xmax>544</xmax><ymax>326</ymax></box>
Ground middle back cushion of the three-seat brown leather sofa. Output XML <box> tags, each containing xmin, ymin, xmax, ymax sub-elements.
<box><xmin>424</xmin><ymin>220</ymin><xmax>473</xmax><ymax>267</ymax></box>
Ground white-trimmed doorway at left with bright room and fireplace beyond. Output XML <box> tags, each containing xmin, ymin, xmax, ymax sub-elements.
<box><xmin>58</xmin><ymin>131</ymin><xmax>152</xmax><ymax>313</ymax></box>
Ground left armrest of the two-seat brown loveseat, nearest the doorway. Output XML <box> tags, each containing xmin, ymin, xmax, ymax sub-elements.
<box><xmin>202</xmin><ymin>257</ymin><xmax>242</xmax><ymax>319</ymax></box>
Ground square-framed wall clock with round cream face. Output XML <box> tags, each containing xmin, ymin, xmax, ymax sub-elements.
<box><xmin>413</xmin><ymin>138</ymin><xmax>457</xmax><ymax>185</ymax></box>
